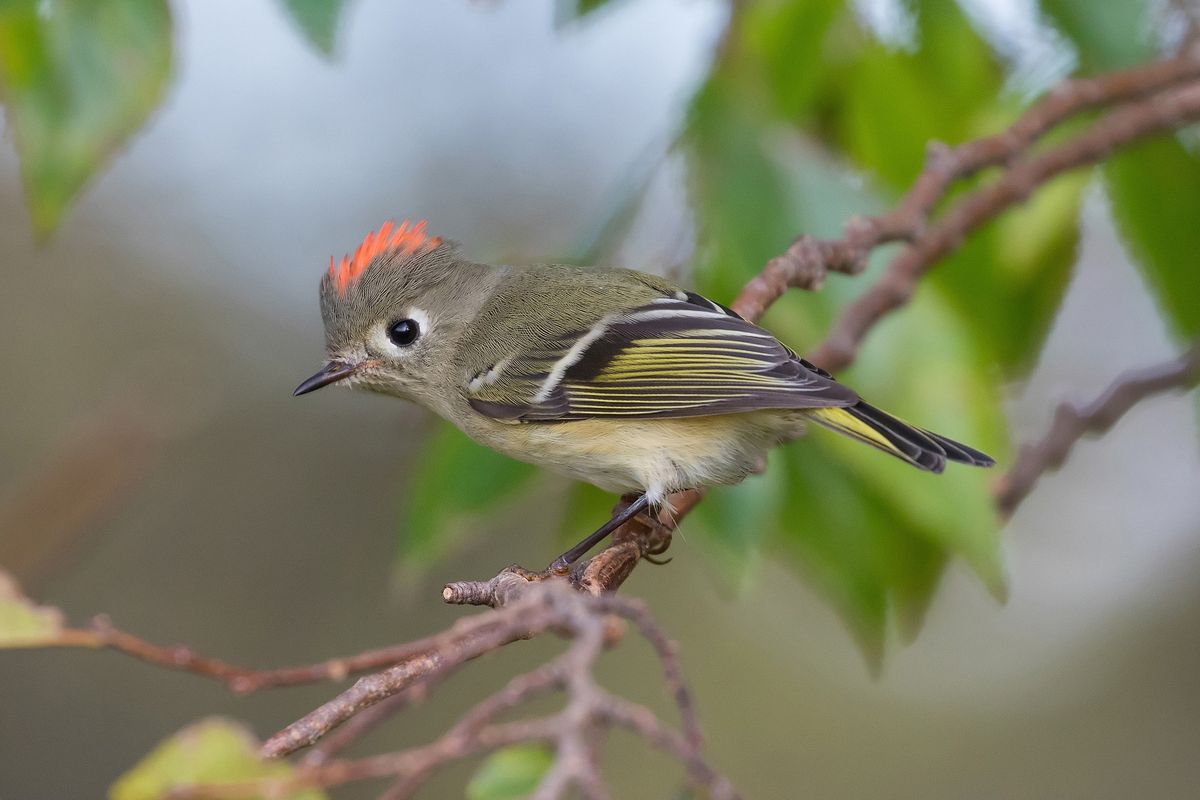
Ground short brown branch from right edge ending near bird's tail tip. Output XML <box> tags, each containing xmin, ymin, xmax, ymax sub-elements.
<box><xmin>995</xmin><ymin>342</ymin><xmax>1200</xmax><ymax>516</ymax></box>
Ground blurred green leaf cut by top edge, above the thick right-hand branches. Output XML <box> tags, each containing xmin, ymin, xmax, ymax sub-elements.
<box><xmin>1042</xmin><ymin>0</ymin><xmax>1153</xmax><ymax>73</ymax></box>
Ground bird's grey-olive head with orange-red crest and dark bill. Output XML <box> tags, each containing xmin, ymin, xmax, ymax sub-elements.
<box><xmin>295</xmin><ymin>221</ymin><xmax>486</xmax><ymax>405</ymax></box>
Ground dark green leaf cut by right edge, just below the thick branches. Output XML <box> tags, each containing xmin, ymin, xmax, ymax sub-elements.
<box><xmin>1104</xmin><ymin>137</ymin><xmax>1200</xmax><ymax>337</ymax></box>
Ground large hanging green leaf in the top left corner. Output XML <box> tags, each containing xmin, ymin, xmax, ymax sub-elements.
<box><xmin>0</xmin><ymin>0</ymin><xmax>172</xmax><ymax>235</ymax></box>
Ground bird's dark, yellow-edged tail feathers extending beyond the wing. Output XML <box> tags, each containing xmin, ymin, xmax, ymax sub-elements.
<box><xmin>808</xmin><ymin>402</ymin><xmax>996</xmax><ymax>473</ymax></box>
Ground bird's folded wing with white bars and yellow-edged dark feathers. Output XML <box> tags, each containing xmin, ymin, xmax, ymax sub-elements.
<box><xmin>466</xmin><ymin>291</ymin><xmax>858</xmax><ymax>422</ymax></box>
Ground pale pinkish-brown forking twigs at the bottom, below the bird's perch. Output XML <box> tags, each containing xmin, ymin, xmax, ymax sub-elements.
<box><xmin>168</xmin><ymin>581</ymin><xmax>738</xmax><ymax>800</ymax></box>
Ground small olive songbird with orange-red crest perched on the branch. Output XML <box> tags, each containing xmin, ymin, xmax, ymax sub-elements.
<box><xmin>295</xmin><ymin>221</ymin><xmax>994</xmax><ymax>572</ymax></box>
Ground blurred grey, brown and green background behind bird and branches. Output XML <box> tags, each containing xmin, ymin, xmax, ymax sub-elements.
<box><xmin>0</xmin><ymin>0</ymin><xmax>1200</xmax><ymax>800</ymax></box>
